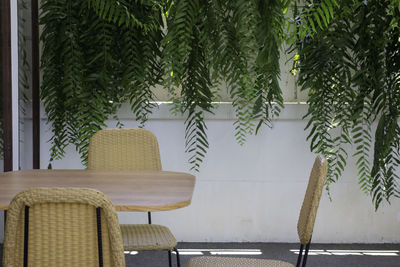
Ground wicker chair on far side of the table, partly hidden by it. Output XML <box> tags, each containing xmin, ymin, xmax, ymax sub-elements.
<box><xmin>88</xmin><ymin>129</ymin><xmax>180</xmax><ymax>267</ymax></box>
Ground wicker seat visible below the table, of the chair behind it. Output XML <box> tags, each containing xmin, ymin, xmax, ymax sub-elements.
<box><xmin>121</xmin><ymin>224</ymin><xmax>177</xmax><ymax>250</ymax></box>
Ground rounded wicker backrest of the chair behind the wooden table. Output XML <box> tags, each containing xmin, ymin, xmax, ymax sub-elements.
<box><xmin>88</xmin><ymin>129</ymin><xmax>161</xmax><ymax>171</ymax></box>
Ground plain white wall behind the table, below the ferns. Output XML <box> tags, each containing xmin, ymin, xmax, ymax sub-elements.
<box><xmin>22</xmin><ymin>105</ymin><xmax>400</xmax><ymax>243</ymax></box>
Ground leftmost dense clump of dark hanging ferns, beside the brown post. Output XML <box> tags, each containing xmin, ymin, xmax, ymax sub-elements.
<box><xmin>40</xmin><ymin>0</ymin><xmax>163</xmax><ymax>168</ymax></box>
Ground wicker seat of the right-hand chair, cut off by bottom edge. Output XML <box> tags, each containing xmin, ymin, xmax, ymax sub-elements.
<box><xmin>186</xmin><ymin>257</ymin><xmax>294</xmax><ymax>267</ymax></box>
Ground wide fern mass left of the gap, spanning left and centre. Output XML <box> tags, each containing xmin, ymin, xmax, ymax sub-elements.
<box><xmin>41</xmin><ymin>0</ymin><xmax>287</xmax><ymax>170</ymax></box>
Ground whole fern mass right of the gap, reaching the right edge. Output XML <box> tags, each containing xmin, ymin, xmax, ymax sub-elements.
<box><xmin>297</xmin><ymin>0</ymin><xmax>400</xmax><ymax>208</ymax></box>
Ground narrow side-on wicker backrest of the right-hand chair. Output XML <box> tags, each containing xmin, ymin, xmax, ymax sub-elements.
<box><xmin>297</xmin><ymin>155</ymin><xmax>328</xmax><ymax>245</ymax></box>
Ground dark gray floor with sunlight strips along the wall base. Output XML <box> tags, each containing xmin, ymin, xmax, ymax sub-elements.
<box><xmin>0</xmin><ymin>242</ymin><xmax>400</xmax><ymax>267</ymax></box>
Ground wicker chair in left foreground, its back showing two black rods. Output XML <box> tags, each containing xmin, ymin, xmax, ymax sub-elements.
<box><xmin>3</xmin><ymin>188</ymin><xmax>125</xmax><ymax>267</ymax></box>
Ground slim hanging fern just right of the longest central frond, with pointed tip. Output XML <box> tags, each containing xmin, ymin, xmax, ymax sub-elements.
<box><xmin>220</xmin><ymin>1</ymin><xmax>262</xmax><ymax>145</ymax></box>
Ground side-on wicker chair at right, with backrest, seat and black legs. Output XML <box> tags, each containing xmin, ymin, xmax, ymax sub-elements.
<box><xmin>187</xmin><ymin>156</ymin><xmax>328</xmax><ymax>267</ymax></box>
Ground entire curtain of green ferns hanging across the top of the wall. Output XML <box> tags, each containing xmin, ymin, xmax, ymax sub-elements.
<box><xmin>41</xmin><ymin>0</ymin><xmax>400</xmax><ymax>207</ymax></box>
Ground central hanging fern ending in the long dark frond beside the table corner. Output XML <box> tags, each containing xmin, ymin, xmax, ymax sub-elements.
<box><xmin>163</xmin><ymin>1</ymin><xmax>213</xmax><ymax>171</ymax></box>
